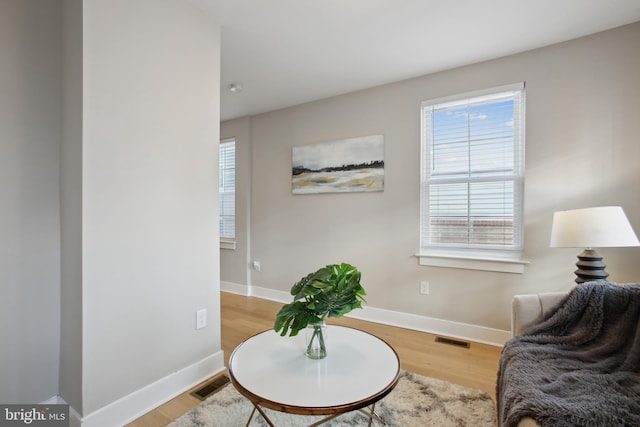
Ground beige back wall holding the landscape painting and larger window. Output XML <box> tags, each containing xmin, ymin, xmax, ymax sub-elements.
<box><xmin>222</xmin><ymin>23</ymin><xmax>640</xmax><ymax>336</ymax></box>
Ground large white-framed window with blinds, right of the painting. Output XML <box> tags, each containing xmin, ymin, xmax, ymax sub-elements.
<box><xmin>419</xmin><ymin>84</ymin><xmax>525</xmax><ymax>272</ymax></box>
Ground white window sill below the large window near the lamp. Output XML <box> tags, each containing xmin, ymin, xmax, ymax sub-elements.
<box><xmin>417</xmin><ymin>254</ymin><xmax>529</xmax><ymax>274</ymax></box>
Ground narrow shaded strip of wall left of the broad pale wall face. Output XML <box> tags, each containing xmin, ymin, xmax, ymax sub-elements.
<box><xmin>58</xmin><ymin>0</ymin><xmax>83</xmax><ymax>412</ymax></box>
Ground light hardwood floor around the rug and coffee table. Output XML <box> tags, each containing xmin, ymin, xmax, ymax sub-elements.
<box><xmin>128</xmin><ymin>292</ymin><xmax>501</xmax><ymax>427</ymax></box>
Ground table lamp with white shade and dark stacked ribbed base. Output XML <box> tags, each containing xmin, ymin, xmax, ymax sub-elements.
<box><xmin>550</xmin><ymin>206</ymin><xmax>640</xmax><ymax>283</ymax></box>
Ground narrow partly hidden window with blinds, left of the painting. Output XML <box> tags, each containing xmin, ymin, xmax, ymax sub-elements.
<box><xmin>218</xmin><ymin>139</ymin><xmax>236</xmax><ymax>249</ymax></box>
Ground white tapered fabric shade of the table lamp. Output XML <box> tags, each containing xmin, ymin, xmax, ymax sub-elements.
<box><xmin>551</xmin><ymin>206</ymin><xmax>640</xmax><ymax>248</ymax></box>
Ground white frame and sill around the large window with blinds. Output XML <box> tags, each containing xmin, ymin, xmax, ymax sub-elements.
<box><xmin>417</xmin><ymin>83</ymin><xmax>528</xmax><ymax>274</ymax></box>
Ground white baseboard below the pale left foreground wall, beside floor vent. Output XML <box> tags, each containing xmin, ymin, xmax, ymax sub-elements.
<box><xmin>63</xmin><ymin>351</ymin><xmax>225</xmax><ymax>427</ymax></box>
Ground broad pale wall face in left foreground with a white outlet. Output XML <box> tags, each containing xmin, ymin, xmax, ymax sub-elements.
<box><xmin>82</xmin><ymin>0</ymin><xmax>223</xmax><ymax>418</ymax></box>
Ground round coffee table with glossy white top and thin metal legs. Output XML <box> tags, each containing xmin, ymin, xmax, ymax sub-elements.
<box><xmin>229</xmin><ymin>325</ymin><xmax>400</xmax><ymax>426</ymax></box>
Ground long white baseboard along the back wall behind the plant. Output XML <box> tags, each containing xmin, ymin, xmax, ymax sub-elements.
<box><xmin>220</xmin><ymin>282</ymin><xmax>511</xmax><ymax>347</ymax></box>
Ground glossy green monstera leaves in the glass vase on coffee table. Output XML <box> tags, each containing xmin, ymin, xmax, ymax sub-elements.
<box><xmin>274</xmin><ymin>263</ymin><xmax>366</xmax><ymax>336</ymax></box>
